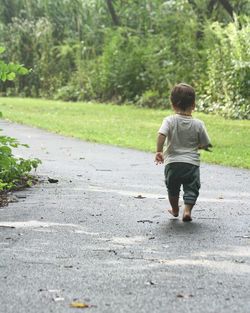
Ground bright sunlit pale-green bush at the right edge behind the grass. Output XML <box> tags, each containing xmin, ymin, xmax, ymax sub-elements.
<box><xmin>198</xmin><ymin>19</ymin><xmax>250</xmax><ymax>119</ymax></box>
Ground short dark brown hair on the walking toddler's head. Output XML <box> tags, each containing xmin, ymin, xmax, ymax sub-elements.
<box><xmin>170</xmin><ymin>83</ymin><xmax>195</xmax><ymax>111</ymax></box>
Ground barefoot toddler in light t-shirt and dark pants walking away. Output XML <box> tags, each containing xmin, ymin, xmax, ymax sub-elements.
<box><xmin>155</xmin><ymin>83</ymin><xmax>212</xmax><ymax>222</ymax></box>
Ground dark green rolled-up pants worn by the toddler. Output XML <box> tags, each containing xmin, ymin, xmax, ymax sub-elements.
<box><xmin>165</xmin><ymin>162</ymin><xmax>200</xmax><ymax>204</ymax></box>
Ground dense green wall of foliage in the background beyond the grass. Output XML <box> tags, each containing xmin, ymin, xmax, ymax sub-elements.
<box><xmin>0</xmin><ymin>0</ymin><xmax>250</xmax><ymax>118</ymax></box>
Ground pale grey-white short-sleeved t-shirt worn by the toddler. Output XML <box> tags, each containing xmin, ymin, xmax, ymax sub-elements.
<box><xmin>159</xmin><ymin>114</ymin><xmax>210</xmax><ymax>166</ymax></box>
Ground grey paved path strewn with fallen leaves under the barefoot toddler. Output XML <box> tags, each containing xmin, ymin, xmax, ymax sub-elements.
<box><xmin>0</xmin><ymin>121</ymin><xmax>250</xmax><ymax>313</ymax></box>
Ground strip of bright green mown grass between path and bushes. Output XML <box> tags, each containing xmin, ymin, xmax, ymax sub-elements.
<box><xmin>0</xmin><ymin>98</ymin><xmax>250</xmax><ymax>168</ymax></box>
